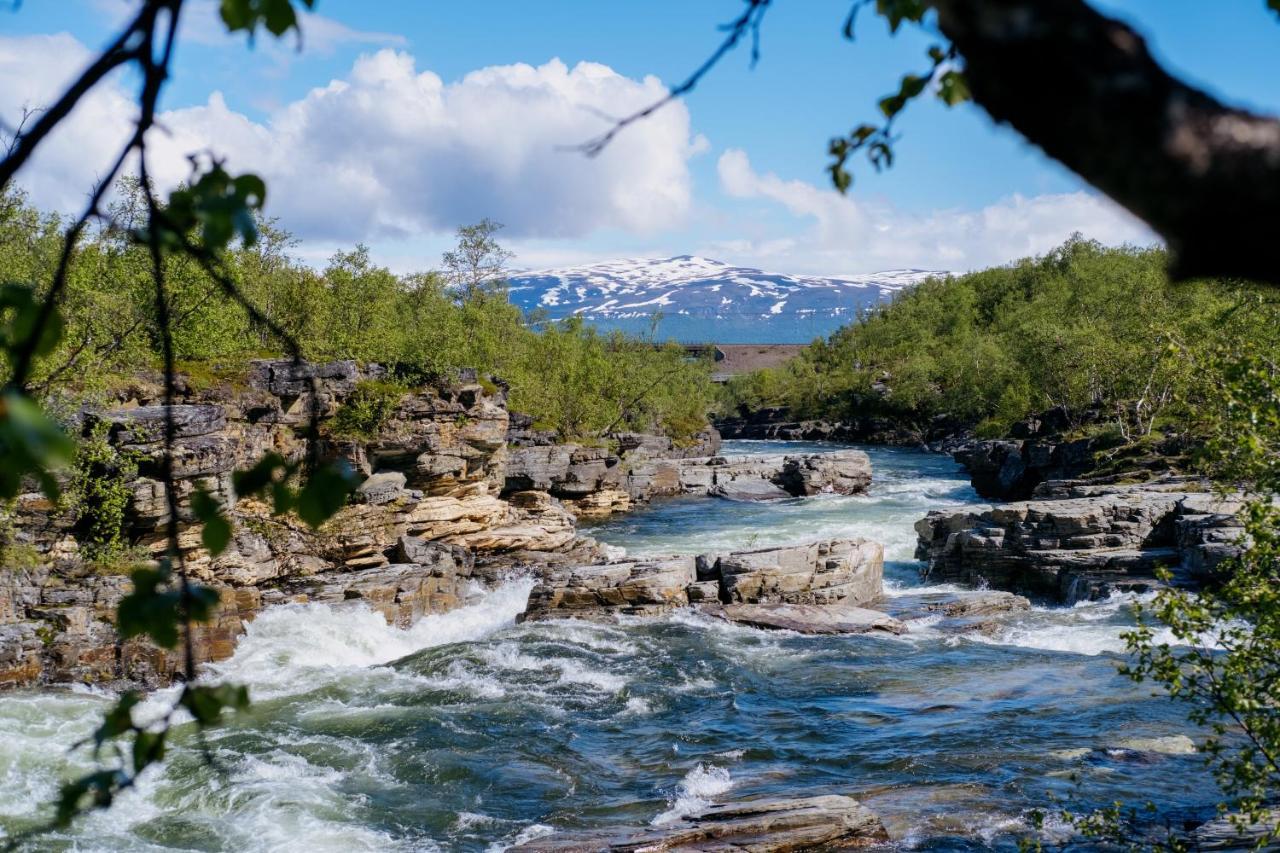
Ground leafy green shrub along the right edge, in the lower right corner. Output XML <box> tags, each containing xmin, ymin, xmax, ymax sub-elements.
<box><xmin>1044</xmin><ymin>342</ymin><xmax>1280</xmax><ymax>850</ymax></box>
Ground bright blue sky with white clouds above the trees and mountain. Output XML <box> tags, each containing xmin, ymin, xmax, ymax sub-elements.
<box><xmin>0</xmin><ymin>0</ymin><xmax>1280</xmax><ymax>274</ymax></box>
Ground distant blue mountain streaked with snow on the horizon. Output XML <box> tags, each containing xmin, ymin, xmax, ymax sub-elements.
<box><xmin>508</xmin><ymin>255</ymin><xmax>940</xmax><ymax>343</ymax></box>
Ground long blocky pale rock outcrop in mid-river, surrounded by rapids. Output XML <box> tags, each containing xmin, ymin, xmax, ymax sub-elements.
<box><xmin>524</xmin><ymin>539</ymin><xmax>884</xmax><ymax>620</ymax></box>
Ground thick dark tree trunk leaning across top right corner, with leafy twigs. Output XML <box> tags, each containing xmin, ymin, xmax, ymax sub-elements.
<box><xmin>582</xmin><ymin>0</ymin><xmax>1280</xmax><ymax>284</ymax></box>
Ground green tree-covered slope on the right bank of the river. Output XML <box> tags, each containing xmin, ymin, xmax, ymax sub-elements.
<box><xmin>721</xmin><ymin>238</ymin><xmax>1280</xmax><ymax>441</ymax></box>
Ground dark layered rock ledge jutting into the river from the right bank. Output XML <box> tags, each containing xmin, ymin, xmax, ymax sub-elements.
<box><xmin>915</xmin><ymin>480</ymin><xmax>1243</xmax><ymax>603</ymax></box>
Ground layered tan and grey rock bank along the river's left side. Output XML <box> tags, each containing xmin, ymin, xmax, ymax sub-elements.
<box><xmin>0</xmin><ymin>361</ymin><xmax>870</xmax><ymax>686</ymax></box>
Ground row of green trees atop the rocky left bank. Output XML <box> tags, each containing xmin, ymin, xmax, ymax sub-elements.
<box><xmin>0</xmin><ymin>186</ymin><xmax>714</xmax><ymax>440</ymax></box>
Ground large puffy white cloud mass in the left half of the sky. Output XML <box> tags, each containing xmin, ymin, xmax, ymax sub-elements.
<box><xmin>0</xmin><ymin>35</ymin><xmax>705</xmax><ymax>241</ymax></box>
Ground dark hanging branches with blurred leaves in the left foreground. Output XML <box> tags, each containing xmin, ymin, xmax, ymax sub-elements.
<box><xmin>0</xmin><ymin>0</ymin><xmax>355</xmax><ymax>826</ymax></box>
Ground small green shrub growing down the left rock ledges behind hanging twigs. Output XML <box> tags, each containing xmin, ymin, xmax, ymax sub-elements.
<box><xmin>67</xmin><ymin>421</ymin><xmax>138</xmax><ymax>565</ymax></box>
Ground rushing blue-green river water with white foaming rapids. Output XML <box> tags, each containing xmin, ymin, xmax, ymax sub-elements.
<box><xmin>0</xmin><ymin>442</ymin><xmax>1216</xmax><ymax>852</ymax></box>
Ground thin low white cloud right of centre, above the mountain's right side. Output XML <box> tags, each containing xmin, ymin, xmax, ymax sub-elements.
<box><xmin>708</xmin><ymin>149</ymin><xmax>1156</xmax><ymax>274</ymax></box>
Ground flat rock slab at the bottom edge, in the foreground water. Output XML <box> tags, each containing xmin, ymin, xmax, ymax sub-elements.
<box><xmin>509</xmin><ymin>794</ymin><xmax>888</xmax><ymax>853</ymax></box>
